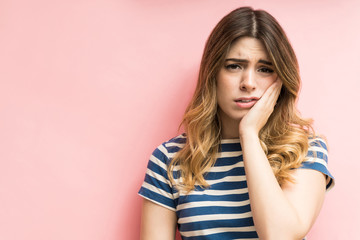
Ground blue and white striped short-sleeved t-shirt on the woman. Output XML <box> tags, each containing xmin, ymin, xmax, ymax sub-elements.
<box><xmin>139</xmin><ymin>134</ymin><xmax>334</xmax><ymax>240</ymax></box>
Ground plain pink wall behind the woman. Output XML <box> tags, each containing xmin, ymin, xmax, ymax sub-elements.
<box><xmin>0</xmin><ymin>0</ymin><xmax>360</xmax><ymax>240</ymax></box>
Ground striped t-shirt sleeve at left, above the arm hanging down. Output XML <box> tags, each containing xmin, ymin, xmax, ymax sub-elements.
<box><xmin>139</xmin><ymin>145</ymin><xmax>176</xmax><ymax>211</ymax></box>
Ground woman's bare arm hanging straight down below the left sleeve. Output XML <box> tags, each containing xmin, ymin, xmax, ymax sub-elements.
<box><xmin>140</xmin><ymin>199</ymin><xmax>177</xmax><ymax>240</ymax></box>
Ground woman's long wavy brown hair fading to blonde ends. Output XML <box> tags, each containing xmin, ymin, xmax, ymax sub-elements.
<box><xmin>168</xmin><ymin>7</ymin><xmax>313</xmax><ymax>192</ymax></box>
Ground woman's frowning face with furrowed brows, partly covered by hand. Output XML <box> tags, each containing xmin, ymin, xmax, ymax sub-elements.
<box><xmin>216</xmin><ymin>37</ymin><xmax>277</xmax><ymax>127</ymax></box>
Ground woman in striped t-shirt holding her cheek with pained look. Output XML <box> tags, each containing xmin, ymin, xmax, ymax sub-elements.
<box><xmin>139</xmin><ymin>7</ymin><xmax>334</xmax><ymax>240</ymax></box>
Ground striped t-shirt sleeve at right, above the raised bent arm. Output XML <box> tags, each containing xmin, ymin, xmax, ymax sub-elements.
<box><xmin>300</xmin><ymin>137</ymin><xmax>335</xmax><ymax>191</ymax></box>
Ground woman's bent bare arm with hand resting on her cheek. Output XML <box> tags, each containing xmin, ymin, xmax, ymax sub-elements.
<box><xmin>239</xmin><ymin>81</ymin><xmax>325</xmax><ymax>240</ymax></box>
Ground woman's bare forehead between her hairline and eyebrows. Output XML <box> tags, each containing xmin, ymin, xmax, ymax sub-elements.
<box><xmin>226</xmin><ymin>37</ymin><xmax>269</xmax><ymax>60</ymax></box>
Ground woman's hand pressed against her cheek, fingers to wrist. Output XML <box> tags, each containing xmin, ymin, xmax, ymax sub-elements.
<box><xmin>239</xmin><ymin>78</ymin><xmax>282</xmax><ymax>138</ymax></box>
